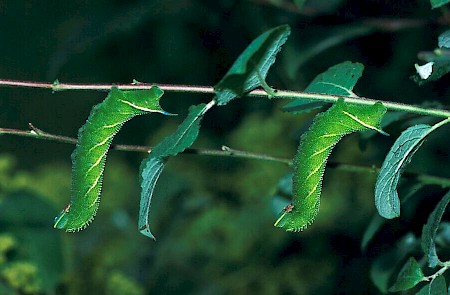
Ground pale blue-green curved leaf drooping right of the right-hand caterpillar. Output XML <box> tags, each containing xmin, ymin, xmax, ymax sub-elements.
<box><xmin>375</xmin><ymin>119</ymin><xmax>448</xmax><ymax>219</ymax></box>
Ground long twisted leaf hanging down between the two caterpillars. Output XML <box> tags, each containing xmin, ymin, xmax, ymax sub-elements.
<box><xmin>138</xmin><ymin>101</ymin><xmax>214</xmax><ymax>239</ymax></box>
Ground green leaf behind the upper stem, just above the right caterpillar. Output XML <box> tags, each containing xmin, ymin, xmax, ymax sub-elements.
<box><xmin>283</xmin><ymin>61</ymin><xmax>364</xmax><ymax>112</ymax></box>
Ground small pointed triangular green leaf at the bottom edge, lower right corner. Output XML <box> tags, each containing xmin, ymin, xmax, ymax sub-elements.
<box><xmin>389</xmin><ymin>257</ymin><xmax>425</xmax><ymax>292</ymax></box>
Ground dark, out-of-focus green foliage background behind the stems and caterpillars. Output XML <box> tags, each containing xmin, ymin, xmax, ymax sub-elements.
<box><xmin>0</xmin><ymin>0</ymin><xmax>450</xmax><ymax>294</ymax></box>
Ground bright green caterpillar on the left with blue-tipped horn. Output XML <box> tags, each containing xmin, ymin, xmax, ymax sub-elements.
<box><xmin>54</xmin><ymin>87</ymin><xmax>169</xmax><ymax>232</ymax></box>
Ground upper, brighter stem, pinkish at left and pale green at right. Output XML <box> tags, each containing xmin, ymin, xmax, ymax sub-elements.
<box><xmin>0</xmin><ymin>80</ymin><xmax>450</xmax><ymax>118</ymax></box>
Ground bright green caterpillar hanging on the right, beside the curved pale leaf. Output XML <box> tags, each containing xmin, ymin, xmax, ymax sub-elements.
<box><xmin>274</xmin><ymin>98</ymin><xmax>386</xmax><ymax>231</ymax></box>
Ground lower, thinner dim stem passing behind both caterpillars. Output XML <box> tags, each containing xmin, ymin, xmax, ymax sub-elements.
<box><xmin>0</xmin><ymin>123</ymin><xmax>450</xmax><ymax>187</ymax></box>
